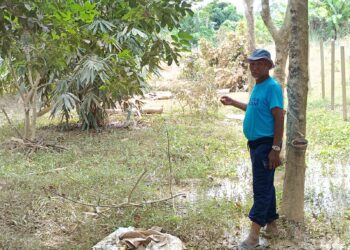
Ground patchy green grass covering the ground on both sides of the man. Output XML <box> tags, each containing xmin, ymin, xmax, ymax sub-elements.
<box><xmin>0</xmin><ymin>39</ymin><xmax>350</xmax><ymax>250</ymax></box>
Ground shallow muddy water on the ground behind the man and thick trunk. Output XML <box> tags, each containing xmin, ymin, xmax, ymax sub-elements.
<box><xmin>180</xmin><ymin>158</ymin><xmax>350</xmax><ymax>217</ymax></box>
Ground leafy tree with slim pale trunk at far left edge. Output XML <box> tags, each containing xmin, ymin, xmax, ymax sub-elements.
<box><xmin>0</xmin><ymin>1</ymin><xmax>72</xmax><ymax>140</ymax></box>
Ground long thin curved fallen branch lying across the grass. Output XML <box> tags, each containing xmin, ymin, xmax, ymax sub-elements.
<box><xmin>51</xmin><ymin>190</ymin><xmax>186</xmax><ymax>208</ymax></box>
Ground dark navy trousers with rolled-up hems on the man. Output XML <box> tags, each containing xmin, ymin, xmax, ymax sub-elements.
<box><xmin>248</xmin><ymin>137</ymin><xmax>278</xmax><ymax>227</ymax></box>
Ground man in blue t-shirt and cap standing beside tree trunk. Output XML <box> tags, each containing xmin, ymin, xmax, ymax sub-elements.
<box><xmin>220</xmin><ymin>49</ymin><xmax>284</xmax><ymax>250</ymax></box>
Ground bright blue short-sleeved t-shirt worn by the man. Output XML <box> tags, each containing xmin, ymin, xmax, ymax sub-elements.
<box><xmin>243</xmin><ymin>77</ymin><xmax>283</xmax><ymax>141</ymax></box>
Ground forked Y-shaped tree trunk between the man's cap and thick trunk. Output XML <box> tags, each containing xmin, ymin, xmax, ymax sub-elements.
<box><xmin>261</xmin><ymin>0</ymin><xmax>291</xmax><ymax>87</ymax></box>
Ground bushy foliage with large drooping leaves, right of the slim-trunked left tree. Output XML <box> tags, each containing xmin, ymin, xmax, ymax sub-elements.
<box><xmin>47</xmin><ymin>1</ymin><xmax>192</xmax><ymax>129</ymax></box>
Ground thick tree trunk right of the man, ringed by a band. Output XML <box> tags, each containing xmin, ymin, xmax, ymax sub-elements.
<box><xmin>282</xmin><ymin>0</ymin><xmax>309</xmax><ymax>222</ymax></box>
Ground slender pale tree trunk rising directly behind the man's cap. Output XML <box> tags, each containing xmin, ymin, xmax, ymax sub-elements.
<box><xmin>244</xmin><ymin>0</ymin><xmax>256</xmax><ymax>92</ymax></box>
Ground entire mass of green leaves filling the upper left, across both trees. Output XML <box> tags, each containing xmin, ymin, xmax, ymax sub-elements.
<box><xmin>0</xmin><ymin>0</ymin><xmax>192</xmax><ymax>129</ymax></box>
